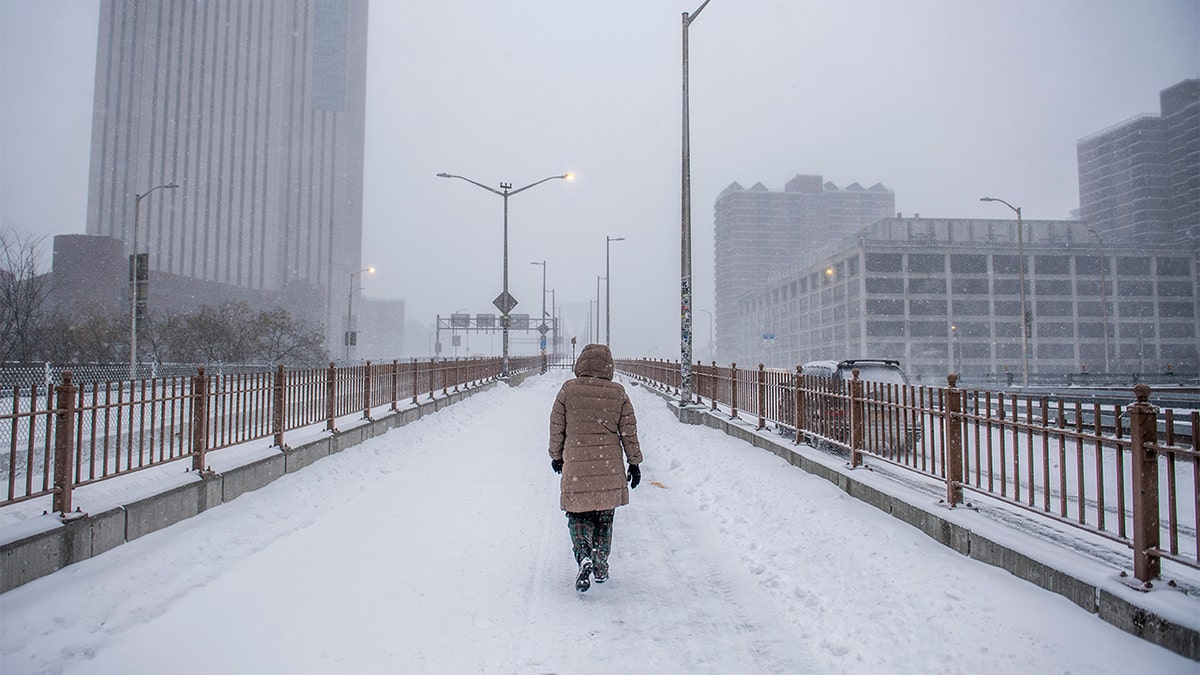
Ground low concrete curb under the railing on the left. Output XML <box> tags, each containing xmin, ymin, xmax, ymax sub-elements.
<box><xmin>0</xmin><ymin>374</ymin><xmax>501</xmax><ymax>592</ymax></box>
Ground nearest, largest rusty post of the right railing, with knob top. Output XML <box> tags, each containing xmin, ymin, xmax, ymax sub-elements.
<box><xmin>1126</xmin><ymin>384</ymin><xmax>1162</xmax><ymax>583</ymax></box>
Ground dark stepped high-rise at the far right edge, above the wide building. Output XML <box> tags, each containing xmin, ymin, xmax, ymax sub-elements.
<box><xmin>1078</xmin><ymin>79</ymin><xmax>1200</xmax><ymax>246</ymax></box>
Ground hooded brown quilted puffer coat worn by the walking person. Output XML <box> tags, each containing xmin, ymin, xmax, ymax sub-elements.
<box><xmin>550</xmin><ymin>345</ymin><xmax>642</xmax><ymax>513</ymax></box>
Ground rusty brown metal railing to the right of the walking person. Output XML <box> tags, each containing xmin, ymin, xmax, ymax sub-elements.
<box><xmin>617</xmin><ymin>359</ymin><xmax>1200</xmax><ymax>583</ymax></box>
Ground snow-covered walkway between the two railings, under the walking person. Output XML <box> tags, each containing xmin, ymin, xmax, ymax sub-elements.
<box><xmin>0</xmin><ymin>374</ymin><xmax>1198</xmax><ymax>674</ymax></box>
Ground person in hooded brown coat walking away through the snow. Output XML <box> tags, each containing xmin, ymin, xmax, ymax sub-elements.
<box><xmin>550</xmin><ymin>345</ymin><xmax>642</xmax><ymax>592</ymax></box>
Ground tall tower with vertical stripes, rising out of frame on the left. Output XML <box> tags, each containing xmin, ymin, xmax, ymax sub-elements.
<box><xmin>88</xmin><ymin>0</ymin><xmax>367</xmax><ymax>353</ymax></box>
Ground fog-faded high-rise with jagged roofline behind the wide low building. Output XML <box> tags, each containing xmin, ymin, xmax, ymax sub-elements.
<box><xmin>714</xmin><ymin>175</ymin><xmax>895</xmax><ymax>359</ymax></box>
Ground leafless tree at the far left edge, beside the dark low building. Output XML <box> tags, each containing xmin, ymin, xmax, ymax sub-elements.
<box><xmin>0</xmin><ymin>226</ymin><xmax>49</xmax><ymax>362</ymax></box>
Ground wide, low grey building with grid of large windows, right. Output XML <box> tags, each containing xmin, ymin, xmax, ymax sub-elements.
<box><xmin>722</xmin><ymin>217</ymin><xmax>1200</xmax><ymax>383</ymax></box>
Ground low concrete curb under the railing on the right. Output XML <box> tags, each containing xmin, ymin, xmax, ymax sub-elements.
<box><xmin>644</xmin><ymin>386</ymin><xmax>1200</xmax><ymax>661</ymax></box>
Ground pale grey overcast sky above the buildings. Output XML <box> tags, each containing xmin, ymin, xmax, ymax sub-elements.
<box><xmin>0</xmin><ymin>0</ymin><xmax>1200</xmax><ymax>359</ymax></box>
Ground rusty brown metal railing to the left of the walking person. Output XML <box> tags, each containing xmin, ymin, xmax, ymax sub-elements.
<box><xmin>0</xmin><ymin>357</ymin><xmax>540</xmax><ymax>513</ymax></box>
